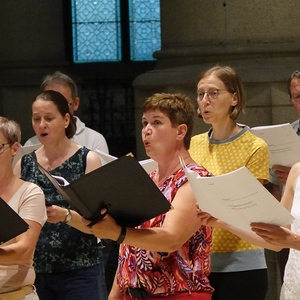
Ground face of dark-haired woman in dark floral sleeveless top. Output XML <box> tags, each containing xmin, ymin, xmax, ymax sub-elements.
<box><xmin>32</xmin><ymin>99</ymin><xmax>70</xmax><ymax>144</ymax></box>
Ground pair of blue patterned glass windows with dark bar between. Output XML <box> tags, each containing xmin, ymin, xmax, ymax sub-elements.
<box><xmin>71</xmin><ymin>0</ymin><xmax>161</xmax><ymax>63</ymax></box>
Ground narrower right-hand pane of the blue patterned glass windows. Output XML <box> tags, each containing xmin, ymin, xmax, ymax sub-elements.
<box><xmin>129</xmin><ymin>0</ymin><xmax>161</xmax><ymax>60</ymax></box>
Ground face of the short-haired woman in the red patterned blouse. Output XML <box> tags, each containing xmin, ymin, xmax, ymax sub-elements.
<box><xmin>142</xmin><ymin>110</ymin><xmax>186</xmax><ymax>160</ymax></box>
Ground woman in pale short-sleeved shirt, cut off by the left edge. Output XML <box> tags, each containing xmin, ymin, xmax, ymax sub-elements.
<box><xmin>0</xmin><ymin>117</ymin><xmax>46</xmax><ymax>300</ymax></box>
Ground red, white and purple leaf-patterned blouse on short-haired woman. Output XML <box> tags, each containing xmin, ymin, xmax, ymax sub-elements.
<box><xmin>117</xmin><ymin>164</ymin><xmax>213</xmax><ymax>296</ymax></box>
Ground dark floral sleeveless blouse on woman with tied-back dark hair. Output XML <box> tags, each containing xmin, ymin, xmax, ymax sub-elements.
<box><xmin>21</xmin><ymin>147</ymin><xmax>99</xmax><ymax>273</ymax></box>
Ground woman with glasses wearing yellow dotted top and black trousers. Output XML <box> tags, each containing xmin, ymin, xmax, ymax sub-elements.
<box><xmin>189</xmin><ymin>66</ymin><xmax>269</xmax><ymax>300</ymax></box>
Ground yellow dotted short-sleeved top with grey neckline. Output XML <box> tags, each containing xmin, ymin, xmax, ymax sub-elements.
<box><xmin>189</xmin><ymin>126</ymin><xmax>269</xmax><ymax>253</ymax></box>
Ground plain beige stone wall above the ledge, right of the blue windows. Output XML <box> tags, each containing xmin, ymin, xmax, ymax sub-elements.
<box><xmin>161</xmin><ymin>0</ymin><xmax>300</xmax><ymax>49</ymax></box>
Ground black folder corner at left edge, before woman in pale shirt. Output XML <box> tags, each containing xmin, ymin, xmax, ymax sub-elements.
<box><xmin>0</xmin><ymin>198</ymin><xmax>29</xmax><ymax>244</ymax></box>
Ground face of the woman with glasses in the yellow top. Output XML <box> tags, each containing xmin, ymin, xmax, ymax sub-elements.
<box><xmin>197</xmin><ymin>75</ymin><xmax>237</xmax><ymax>125</ymax></box>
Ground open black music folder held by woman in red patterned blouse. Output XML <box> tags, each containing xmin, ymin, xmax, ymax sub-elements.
<box><xmin>39</xmin><ymin>156</ymin><xmax>172</xmax><ymax>227</ymax></box>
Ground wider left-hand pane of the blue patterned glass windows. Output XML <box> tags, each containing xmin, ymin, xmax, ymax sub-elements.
<box><xmin>72</xmin><ymin>0</ymin><xmax>121</xmax><ymax>63</ymax></box>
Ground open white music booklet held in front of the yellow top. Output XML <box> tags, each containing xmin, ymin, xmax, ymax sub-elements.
<box><xmin>180</xmin><ymin>161</ymin><xmax>293</xmax><ymax>230</ymax></box>
